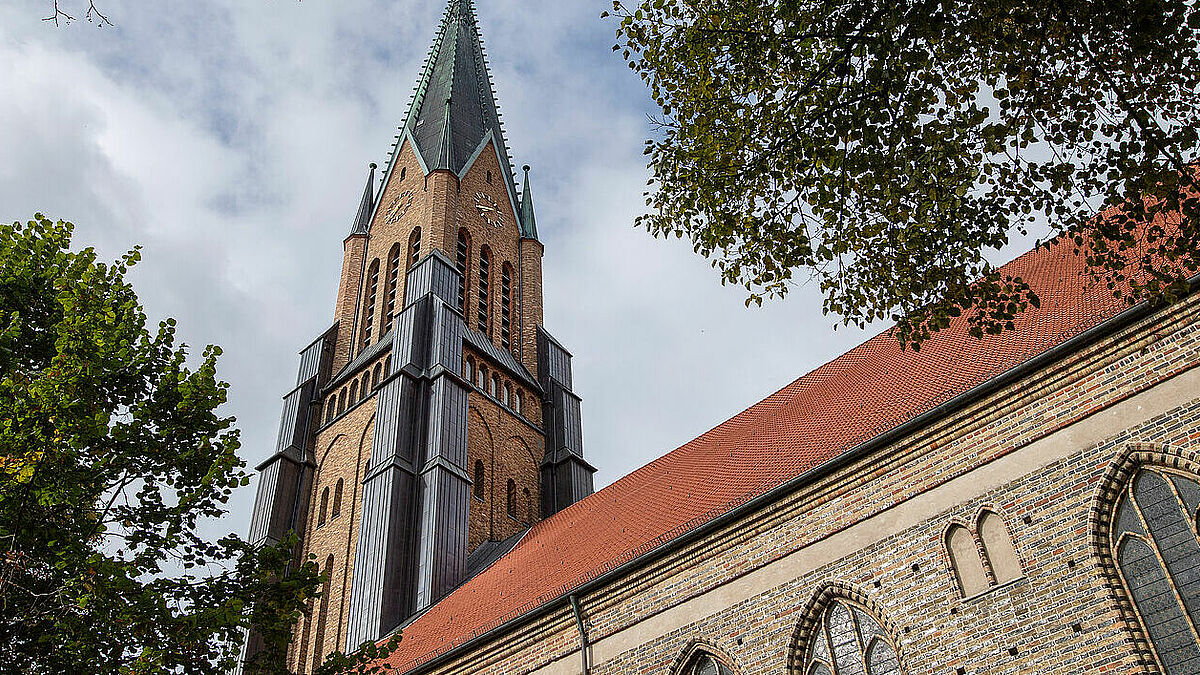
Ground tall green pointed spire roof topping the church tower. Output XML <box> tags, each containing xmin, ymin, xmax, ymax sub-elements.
<box><xmin>403</xmin><ymin>0</ymin><xmax>516</xmax><ymax>189</ymax></box>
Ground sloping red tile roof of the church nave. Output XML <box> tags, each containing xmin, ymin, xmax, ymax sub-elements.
<box><xmin>389</xmin><ymin>235</ymin><xmax>1142</xmax><ymax>670</ymax></box>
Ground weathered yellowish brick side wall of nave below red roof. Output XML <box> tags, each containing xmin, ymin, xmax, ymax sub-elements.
<box><xmin>400</xmin><ymin>295</ymin><xmax>1200</xmax><ymax>675</ymax></box>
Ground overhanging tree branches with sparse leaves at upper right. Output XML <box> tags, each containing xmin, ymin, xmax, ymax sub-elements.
<box><xmin>605</xmin><ymin>0</ymin><xmax>1200</xmax><ymax>347</ymax></box>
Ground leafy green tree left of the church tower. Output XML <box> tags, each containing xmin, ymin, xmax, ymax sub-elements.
<box><xmin>0</xmin><ymin>215</ymin><xmax>394</xmax><ymax>675</ymax></box>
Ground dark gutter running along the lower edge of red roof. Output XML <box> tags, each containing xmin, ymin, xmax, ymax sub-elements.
<box><xmin>408</xmin><ymin>274</ymin><xmax>1200</xmax><ymax>675</ymax></box>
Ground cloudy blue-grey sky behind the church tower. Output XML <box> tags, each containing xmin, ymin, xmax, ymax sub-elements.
<box><xmin>0</xmin><ymin>0</ymin><xmax>883</xmax><ymax>532</ymax></box>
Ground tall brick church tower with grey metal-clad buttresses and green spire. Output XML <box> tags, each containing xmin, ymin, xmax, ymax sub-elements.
<box><xmin>247</xmin><ymin>0</ymin><xmax>595</xmax><ymax>673</ymax></box>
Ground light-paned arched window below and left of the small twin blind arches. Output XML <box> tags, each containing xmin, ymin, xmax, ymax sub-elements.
<box><xmin>804</xmin><ymin>598</ymin><xmax>902</xmax><ymax>675</ymax></box>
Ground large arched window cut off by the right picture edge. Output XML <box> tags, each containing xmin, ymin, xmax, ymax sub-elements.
<box><xmin>1108</xmin><ymin>467</ymin><xmax>1200</xmax><ymax>675</ymax></box>
